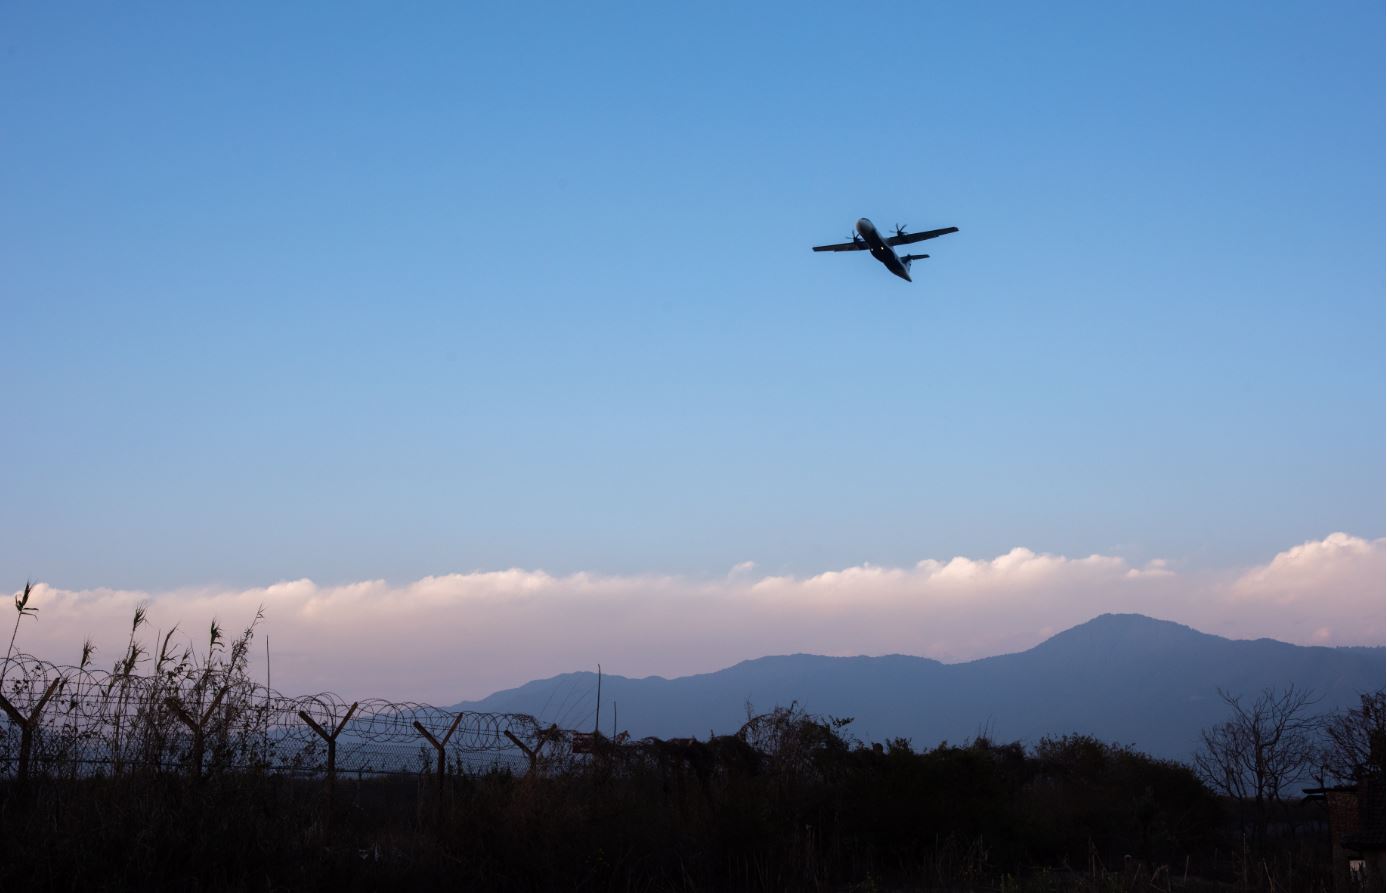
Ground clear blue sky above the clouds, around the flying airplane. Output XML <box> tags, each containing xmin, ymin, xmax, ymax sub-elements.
<box><xmin>0</xmin><ymin>3</ymin><xmax>1384</xmax><ymax>588</ymax></box>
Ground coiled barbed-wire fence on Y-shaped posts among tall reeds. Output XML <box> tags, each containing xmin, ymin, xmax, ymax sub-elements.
<box><xmin>0</xmin><ymin>654</ymin><xmax>571</xmax><ymax>775</ymax></box>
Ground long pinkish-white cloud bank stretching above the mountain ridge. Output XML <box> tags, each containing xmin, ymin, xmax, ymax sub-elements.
<box><xmin>5</xmin><ymin>532</ymin><xmax>1387</xmax><ymax>704</ymax></box>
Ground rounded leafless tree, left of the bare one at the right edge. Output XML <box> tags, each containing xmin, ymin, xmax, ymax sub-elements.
<box><xmin>1194</xmin><ymin>685</ymin><xmax>1319</xmax><ymax>839</ymax></box>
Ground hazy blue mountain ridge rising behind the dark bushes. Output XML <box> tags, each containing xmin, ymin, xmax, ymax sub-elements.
<box><xmin>458</xmin><ymin>614</ymin><xmax>1387</xmax><ymax>760</ymax></box>
